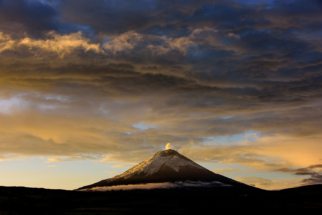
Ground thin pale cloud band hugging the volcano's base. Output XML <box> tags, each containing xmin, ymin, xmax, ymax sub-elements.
<box><xmin>80</xmin><ymin>181</ymin><xmax>231</xmax><ymax>192</ymax></box>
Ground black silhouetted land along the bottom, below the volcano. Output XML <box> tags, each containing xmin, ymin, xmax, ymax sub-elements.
<box><xmin>0</xmin><ymin>185</ymin><xmax>322</xmax><ymax>215</ymax></box>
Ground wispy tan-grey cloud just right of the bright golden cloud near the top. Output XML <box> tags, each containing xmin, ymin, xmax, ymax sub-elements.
<box><xmin>102</xmin><ymin>27</ymin><xmax>227</xmax><ymax>56</ymax></box>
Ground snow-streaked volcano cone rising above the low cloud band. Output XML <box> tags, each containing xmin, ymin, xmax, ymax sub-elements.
<box><xmin>77</xmin><ymin>149</ymin><xmax>256</xmax><ymax>190</ymax></box>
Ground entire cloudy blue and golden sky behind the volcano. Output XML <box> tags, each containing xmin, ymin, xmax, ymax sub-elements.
<box><xmin>0</xmin><ymin>0</ymin><xmax>322</xmax><ymax>190</ymax></box>
